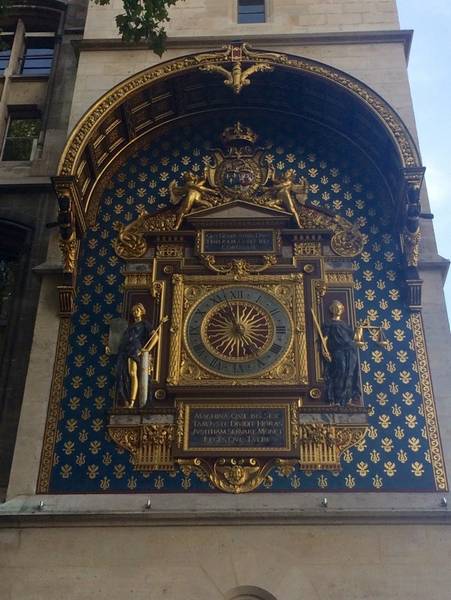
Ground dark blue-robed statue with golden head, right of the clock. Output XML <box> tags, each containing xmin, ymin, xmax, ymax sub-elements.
<box><xmin>323</xmin><ymin>300</ymin><xmax>361</xmax><ymax>406</ymax></box>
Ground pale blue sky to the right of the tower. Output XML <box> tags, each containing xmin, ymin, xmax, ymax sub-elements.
<box><xmin>398</xmin><ymin>0</ymin><xmax>451</xmax><ymax>324</ymax></box>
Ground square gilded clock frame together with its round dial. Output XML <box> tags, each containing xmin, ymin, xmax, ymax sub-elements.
<box><xmin>168</xmin><ymin>275</ymin><xmax>306</xmax><ymax>385</ymax></box>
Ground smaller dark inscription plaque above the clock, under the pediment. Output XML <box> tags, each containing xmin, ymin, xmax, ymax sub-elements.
<box><xmin>202</xmin><ymin>229</ymin><xmax>276</xmax><ymax>254</ymax></box>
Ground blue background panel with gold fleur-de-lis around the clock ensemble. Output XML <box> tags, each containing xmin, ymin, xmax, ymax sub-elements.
<box><xmin>44</xmin><ymin>116</ymin><xmax>446</xmax><ymax>493</ymax></box>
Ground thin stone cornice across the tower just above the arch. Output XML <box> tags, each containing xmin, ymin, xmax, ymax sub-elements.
<box><xmin>72</xmin><ymin>29</ymin><xmax>413</xmax><ymax>61</ymax></box>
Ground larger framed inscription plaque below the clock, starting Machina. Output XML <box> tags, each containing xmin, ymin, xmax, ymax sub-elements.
<box><xmin>177</xmin><ymin>402</ymin><xmax>292</xmax><ymax>456</ymax></box>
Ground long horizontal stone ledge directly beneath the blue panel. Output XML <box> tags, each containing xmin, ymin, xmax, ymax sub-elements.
<box><xmin>0</xmin><ymin>491</ymin><xmax>451</xmax><ymax>528</ymax></box>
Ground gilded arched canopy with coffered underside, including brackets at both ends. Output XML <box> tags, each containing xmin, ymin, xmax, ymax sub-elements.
<box><xmin>54</xmin><ymin>43</ymin><xmax>424</xmax><ymax>307</ymax></box>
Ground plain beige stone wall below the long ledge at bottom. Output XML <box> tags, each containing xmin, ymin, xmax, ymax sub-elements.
<box><xmin>0</xmin><ymin>523</ymin><xmax>451</xmax><ymax>600</ymax></box>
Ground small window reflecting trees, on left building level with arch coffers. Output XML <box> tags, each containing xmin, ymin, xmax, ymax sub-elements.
<box><xmin>2</xmin><ymin>115</ymin><xmax>41</xmax><ymax>161</ymax></box>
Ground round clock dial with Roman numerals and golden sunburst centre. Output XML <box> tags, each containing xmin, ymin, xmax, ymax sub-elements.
<box><xmin>185</xmin><ymin>285</ymin><xmax>293</xmax><ymax>378</ymax></box>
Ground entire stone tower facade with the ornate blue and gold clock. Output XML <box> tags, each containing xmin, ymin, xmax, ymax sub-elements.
<box><xmin>0</xmin><ymin>0</ymin><xmax>451</xmax><ymax>600</ymax></box>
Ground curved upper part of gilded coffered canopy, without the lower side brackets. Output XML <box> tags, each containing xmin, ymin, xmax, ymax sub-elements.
<box><xmin>55</xmin><ymin>44</ymin><xmax>421</xmax><ymax>225</ymax></box>
